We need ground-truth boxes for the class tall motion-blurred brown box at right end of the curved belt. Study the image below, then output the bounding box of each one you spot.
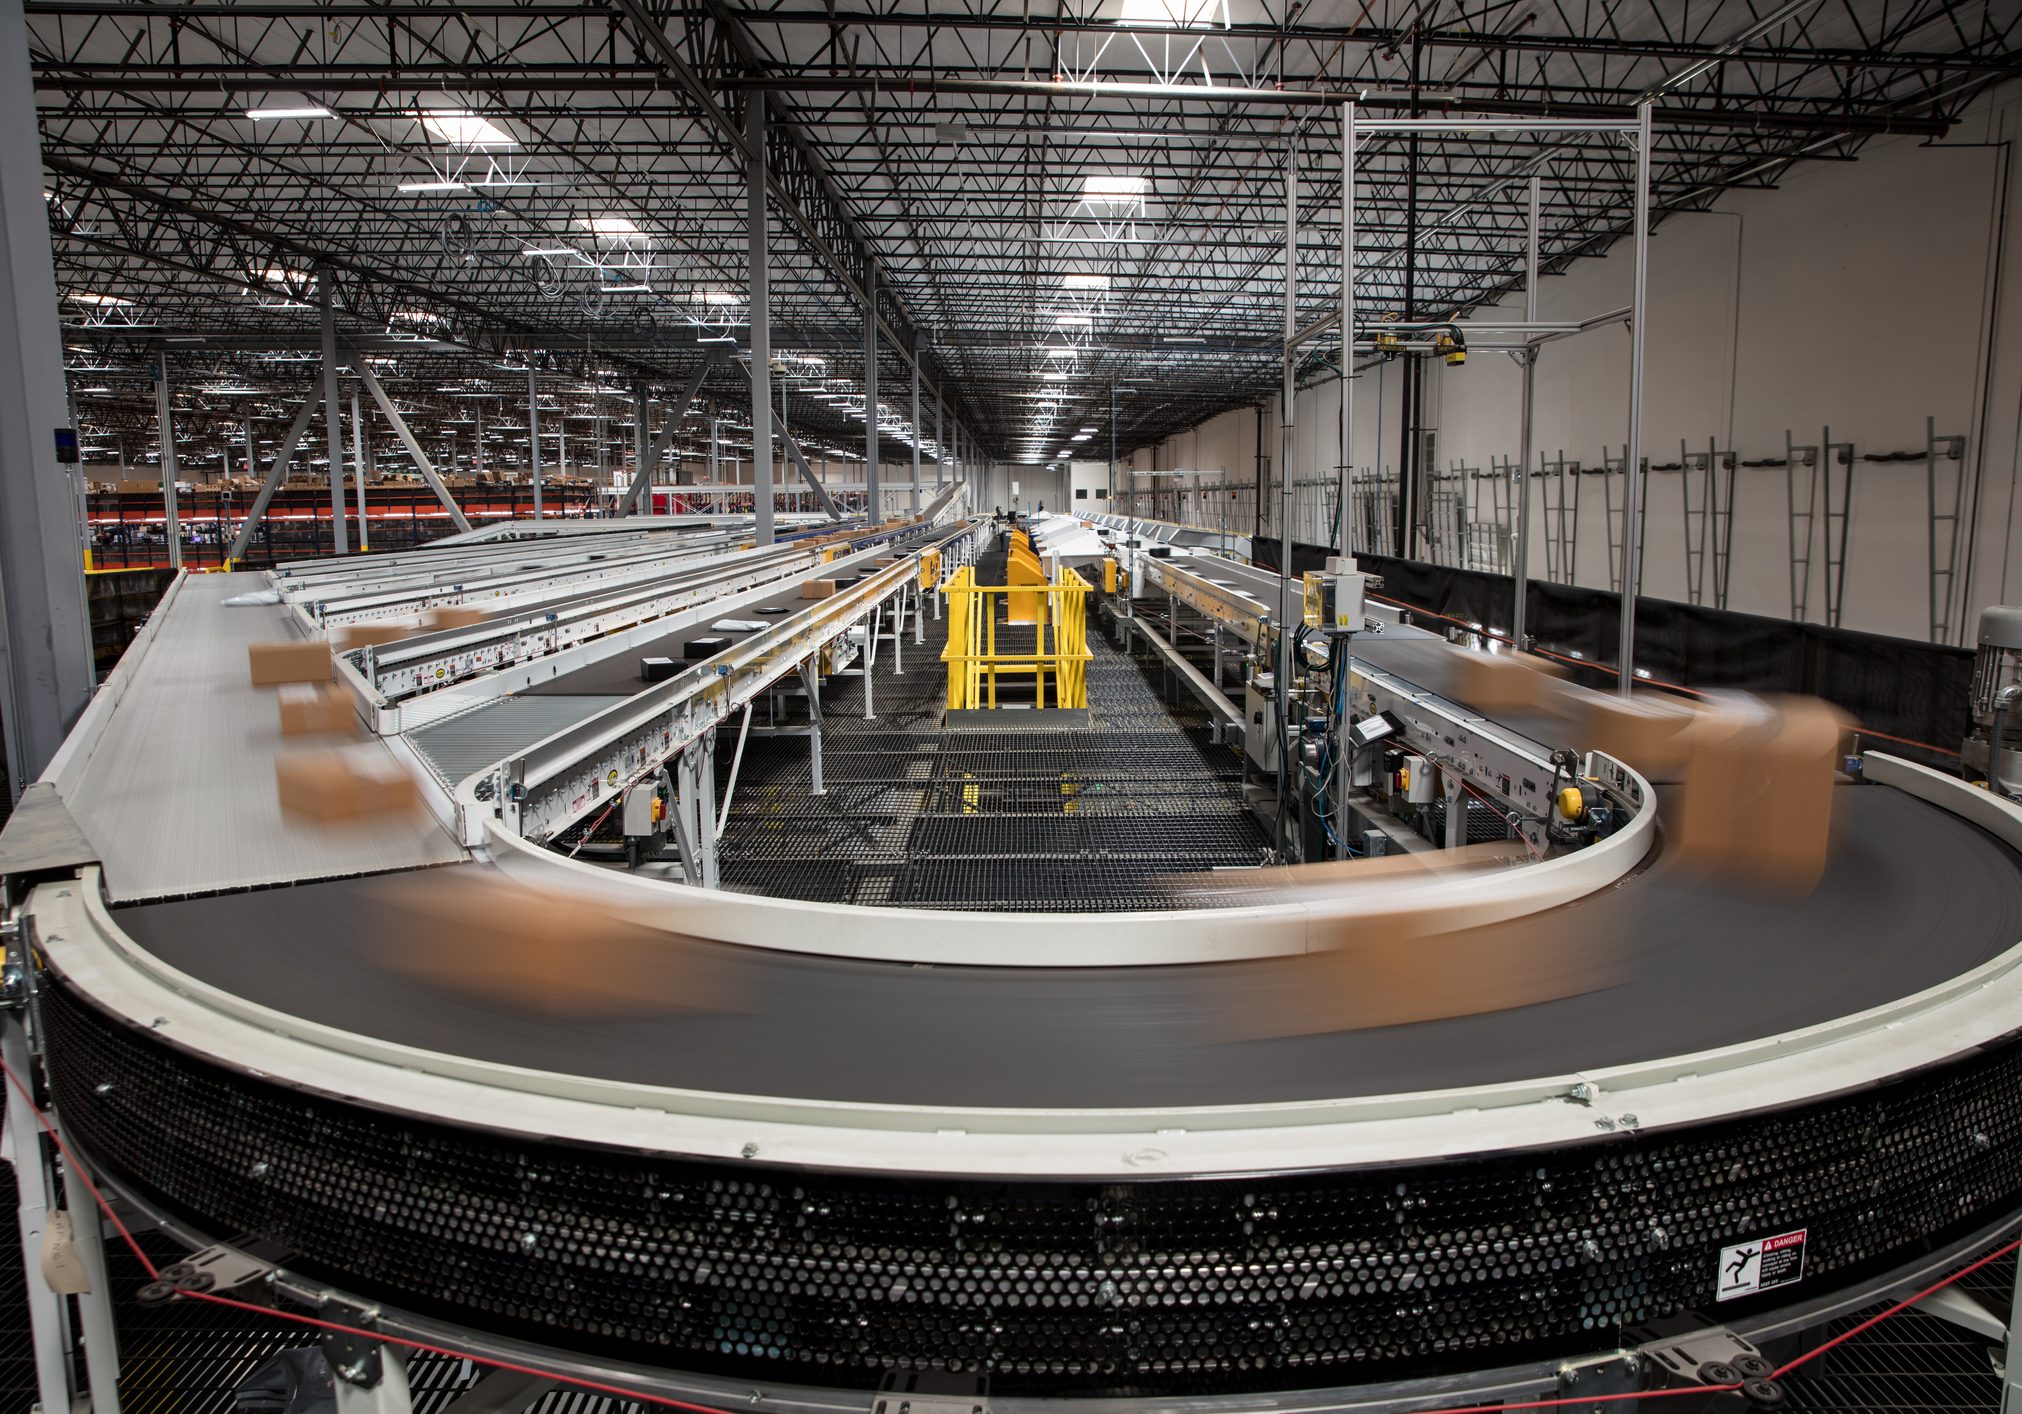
[1670,698,1848,894]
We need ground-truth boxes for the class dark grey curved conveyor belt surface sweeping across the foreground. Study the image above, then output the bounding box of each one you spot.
[119,785,2022,1109]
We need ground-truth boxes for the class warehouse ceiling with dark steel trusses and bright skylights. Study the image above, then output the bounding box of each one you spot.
[26,0,2022,475]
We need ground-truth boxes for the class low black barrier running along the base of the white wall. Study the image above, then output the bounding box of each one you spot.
[1256,540,1973,765]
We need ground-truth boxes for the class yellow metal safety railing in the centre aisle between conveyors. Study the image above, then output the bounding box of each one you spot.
[940,562,1094,712]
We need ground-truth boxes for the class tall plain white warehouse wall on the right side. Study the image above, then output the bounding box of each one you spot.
[1138,85,2022,641]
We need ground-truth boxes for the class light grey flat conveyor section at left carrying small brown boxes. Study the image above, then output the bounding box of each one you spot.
[65,575,463,900]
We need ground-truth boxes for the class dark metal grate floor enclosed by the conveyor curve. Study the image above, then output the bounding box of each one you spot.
[718,590,1268,912]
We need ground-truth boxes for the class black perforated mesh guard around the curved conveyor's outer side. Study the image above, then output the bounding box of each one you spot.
[42,983,2022,1396]
